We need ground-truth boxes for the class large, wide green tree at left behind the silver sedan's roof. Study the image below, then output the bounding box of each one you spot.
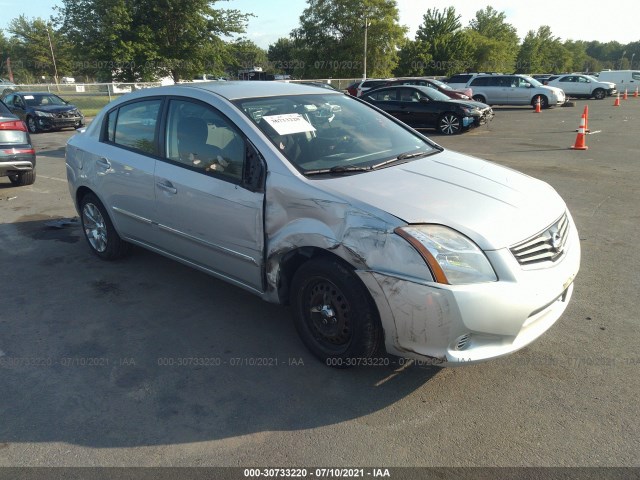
[57,0,248,81]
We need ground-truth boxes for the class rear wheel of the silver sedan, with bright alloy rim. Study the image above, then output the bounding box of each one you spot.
[80,193,131,260]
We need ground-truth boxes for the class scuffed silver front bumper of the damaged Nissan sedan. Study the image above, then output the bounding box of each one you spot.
[360,212,580,366]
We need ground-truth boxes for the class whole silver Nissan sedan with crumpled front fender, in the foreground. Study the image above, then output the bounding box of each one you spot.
[66,82,580,367]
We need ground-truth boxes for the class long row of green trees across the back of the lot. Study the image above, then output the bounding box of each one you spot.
[0,0,640,83]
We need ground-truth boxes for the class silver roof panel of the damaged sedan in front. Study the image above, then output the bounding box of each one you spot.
[171,80,342,100]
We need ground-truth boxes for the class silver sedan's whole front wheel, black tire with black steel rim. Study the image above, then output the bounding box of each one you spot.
[291,257,382,368]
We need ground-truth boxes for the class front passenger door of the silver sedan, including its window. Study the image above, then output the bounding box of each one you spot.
[155,98,264,291]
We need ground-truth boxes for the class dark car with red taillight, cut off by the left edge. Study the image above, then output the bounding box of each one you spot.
[0,100,36,186]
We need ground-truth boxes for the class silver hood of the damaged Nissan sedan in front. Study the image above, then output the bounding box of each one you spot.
[312,151,566,250]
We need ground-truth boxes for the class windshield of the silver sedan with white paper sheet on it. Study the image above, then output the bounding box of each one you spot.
[234,93,439,174]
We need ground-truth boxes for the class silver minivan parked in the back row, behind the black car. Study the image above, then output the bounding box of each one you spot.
[467,75,566,108]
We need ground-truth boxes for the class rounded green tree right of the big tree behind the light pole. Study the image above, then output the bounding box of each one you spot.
[416,7,473,75]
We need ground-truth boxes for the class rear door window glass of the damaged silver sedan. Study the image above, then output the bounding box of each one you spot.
[105,99,162,155]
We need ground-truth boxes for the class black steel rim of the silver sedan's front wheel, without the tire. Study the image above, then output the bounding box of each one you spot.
[305,278,352,350]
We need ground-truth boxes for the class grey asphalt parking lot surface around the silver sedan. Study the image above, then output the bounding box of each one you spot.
[0,98,640,467]
